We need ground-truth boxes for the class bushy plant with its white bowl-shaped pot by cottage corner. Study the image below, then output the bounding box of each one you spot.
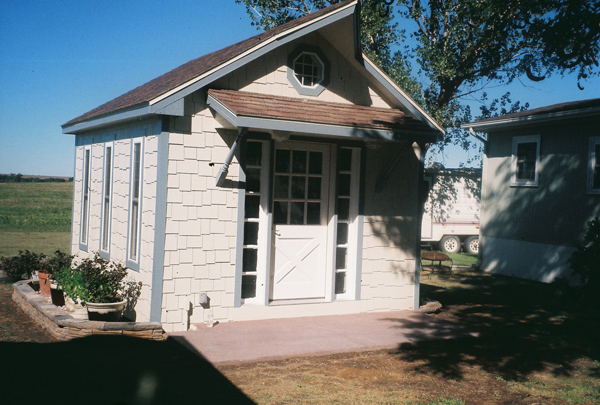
[74,253,142,321]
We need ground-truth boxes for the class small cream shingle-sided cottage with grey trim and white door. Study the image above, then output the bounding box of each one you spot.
[63,1,443,331]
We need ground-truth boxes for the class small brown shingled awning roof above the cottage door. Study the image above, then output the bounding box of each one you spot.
[208,89,439,142]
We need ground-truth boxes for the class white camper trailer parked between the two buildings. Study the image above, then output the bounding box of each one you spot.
[421,169,481,254]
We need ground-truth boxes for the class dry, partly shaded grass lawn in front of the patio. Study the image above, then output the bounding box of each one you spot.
[219,270,600,405]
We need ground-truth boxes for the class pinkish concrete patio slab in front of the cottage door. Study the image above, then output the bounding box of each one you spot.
[167,311,478,364]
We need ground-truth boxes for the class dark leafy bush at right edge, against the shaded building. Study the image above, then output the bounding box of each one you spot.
[569,217,600,298]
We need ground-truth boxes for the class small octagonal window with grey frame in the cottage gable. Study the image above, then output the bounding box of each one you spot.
[288,46,329,96]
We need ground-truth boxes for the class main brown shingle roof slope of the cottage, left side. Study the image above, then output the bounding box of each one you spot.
[63,0,350,126]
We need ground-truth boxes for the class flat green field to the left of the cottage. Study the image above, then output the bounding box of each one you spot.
[0,182,73,256]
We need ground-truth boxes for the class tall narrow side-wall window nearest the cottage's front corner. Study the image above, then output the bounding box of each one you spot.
[127,141,142,263]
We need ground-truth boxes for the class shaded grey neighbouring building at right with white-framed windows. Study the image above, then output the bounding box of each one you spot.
[463,99,600,282]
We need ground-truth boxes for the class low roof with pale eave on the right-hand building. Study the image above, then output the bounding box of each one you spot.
[461,98,600,131]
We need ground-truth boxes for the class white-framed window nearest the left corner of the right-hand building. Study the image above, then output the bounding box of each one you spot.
[511,135,540,186]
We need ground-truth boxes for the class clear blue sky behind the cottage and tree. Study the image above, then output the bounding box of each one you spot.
[0,0,600,176]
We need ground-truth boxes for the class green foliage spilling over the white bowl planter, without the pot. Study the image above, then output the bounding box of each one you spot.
[53,253,142,303]
